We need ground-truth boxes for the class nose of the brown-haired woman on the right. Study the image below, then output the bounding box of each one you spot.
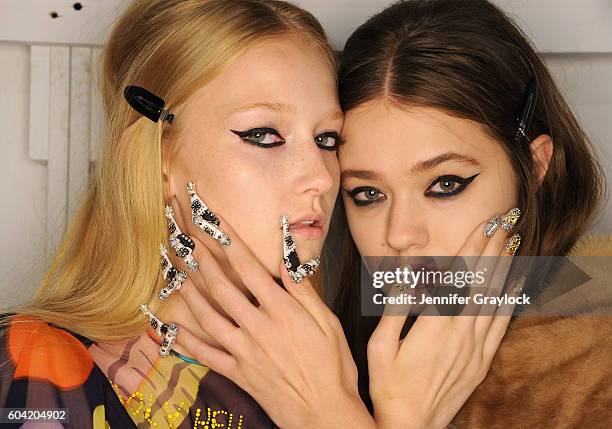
[386,199,430,256]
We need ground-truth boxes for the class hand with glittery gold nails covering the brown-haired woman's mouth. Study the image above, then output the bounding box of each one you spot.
[368,212,518,429]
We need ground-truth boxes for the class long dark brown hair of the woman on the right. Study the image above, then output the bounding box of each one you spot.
[335,0,604,410]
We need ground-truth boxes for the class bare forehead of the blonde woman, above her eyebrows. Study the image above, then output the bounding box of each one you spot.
[184,35,337,113]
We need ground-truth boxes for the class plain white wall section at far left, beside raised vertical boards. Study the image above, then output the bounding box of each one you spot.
[0,43,47,304]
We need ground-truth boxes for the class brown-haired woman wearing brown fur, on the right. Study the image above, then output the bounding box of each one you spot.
[336,0,612,428]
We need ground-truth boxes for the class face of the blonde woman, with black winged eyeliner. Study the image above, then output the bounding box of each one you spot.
[165,36,343,276]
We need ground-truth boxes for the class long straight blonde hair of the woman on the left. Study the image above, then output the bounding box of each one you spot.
[5,0,335,341]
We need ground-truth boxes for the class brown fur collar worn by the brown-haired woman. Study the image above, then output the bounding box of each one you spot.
[449,234,612,429]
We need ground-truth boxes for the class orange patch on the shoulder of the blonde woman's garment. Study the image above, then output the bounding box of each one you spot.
[0,315,94,389]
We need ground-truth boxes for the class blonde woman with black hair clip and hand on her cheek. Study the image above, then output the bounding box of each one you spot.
[0,0,505,429]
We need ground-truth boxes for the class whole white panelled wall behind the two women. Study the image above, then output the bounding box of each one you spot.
[0,0,612,308]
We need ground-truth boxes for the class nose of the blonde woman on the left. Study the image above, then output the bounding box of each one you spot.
[291,139,340,195]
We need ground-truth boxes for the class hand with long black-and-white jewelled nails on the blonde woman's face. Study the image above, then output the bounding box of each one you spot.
[170,204,374,428]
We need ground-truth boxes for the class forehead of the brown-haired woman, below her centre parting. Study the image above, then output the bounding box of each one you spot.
[339,100,502,169]
